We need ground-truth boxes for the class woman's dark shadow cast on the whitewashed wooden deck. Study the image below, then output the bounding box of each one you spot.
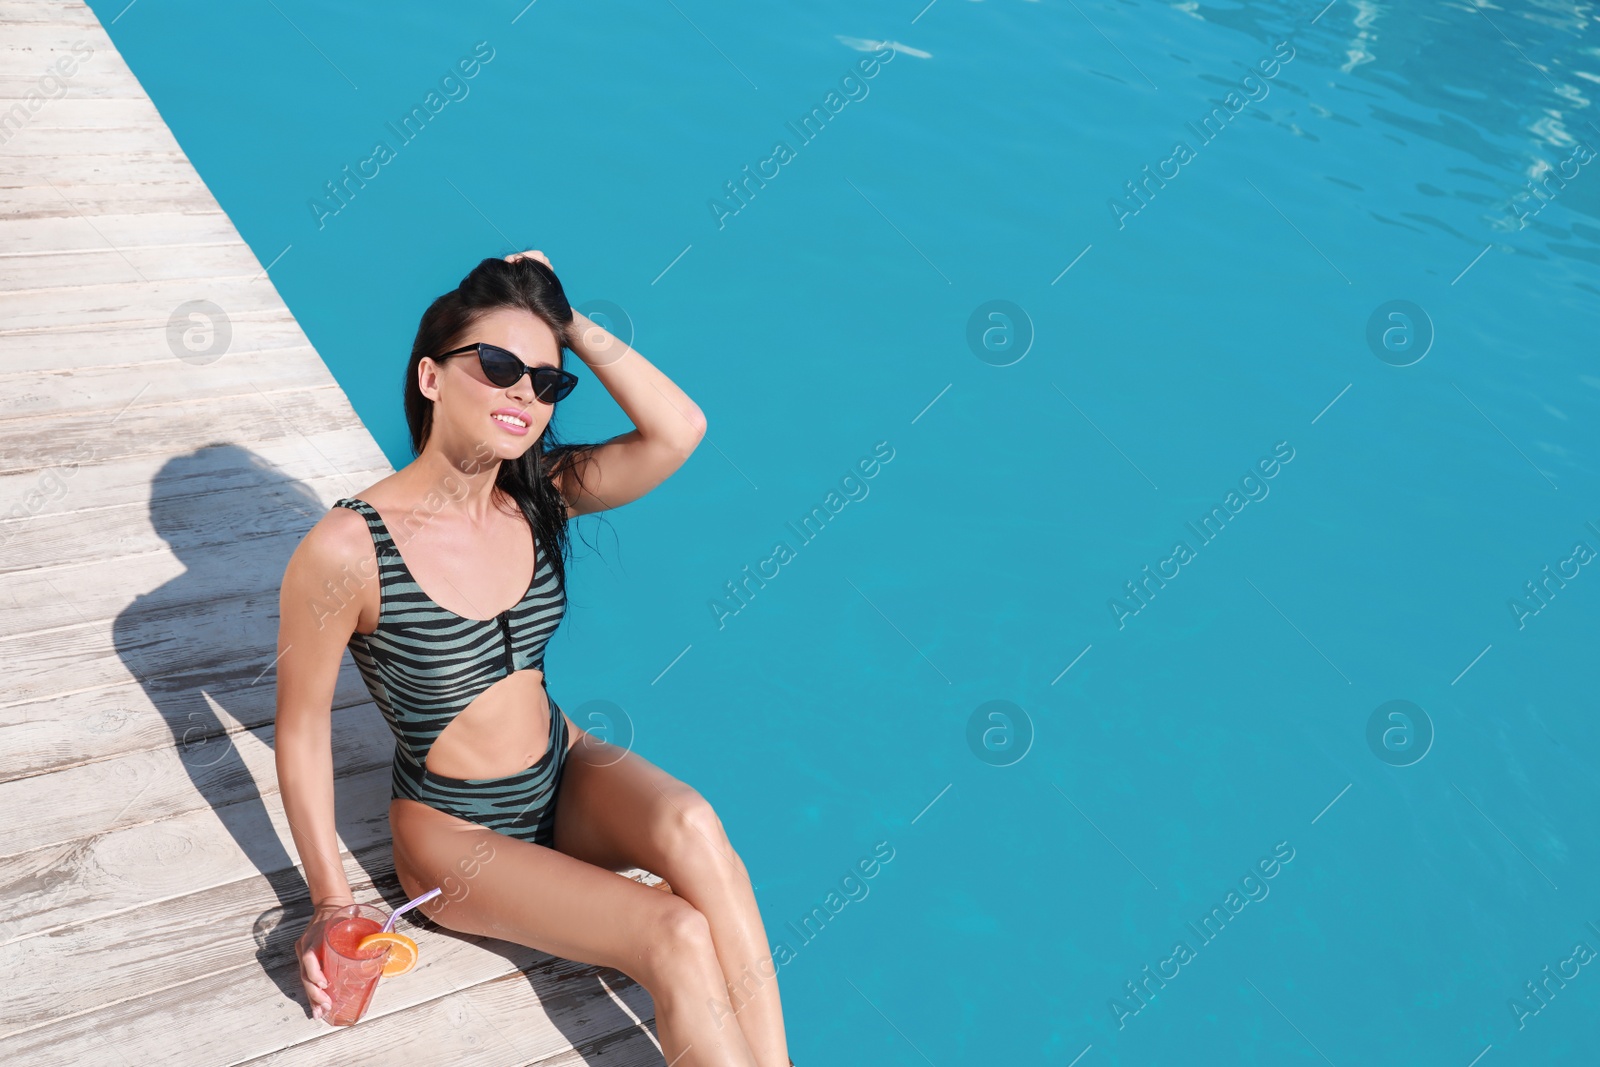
[112,443,652,1062]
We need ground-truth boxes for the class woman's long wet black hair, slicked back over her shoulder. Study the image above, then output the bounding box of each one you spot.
[405,256,597,589]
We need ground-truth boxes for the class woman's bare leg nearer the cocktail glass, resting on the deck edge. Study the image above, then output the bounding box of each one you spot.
[389,798,758,1067]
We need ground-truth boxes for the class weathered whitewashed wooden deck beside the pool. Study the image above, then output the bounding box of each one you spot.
[0,0,662,1067]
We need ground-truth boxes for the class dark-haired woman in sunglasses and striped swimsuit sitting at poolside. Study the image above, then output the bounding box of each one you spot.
[275,251,792,1067]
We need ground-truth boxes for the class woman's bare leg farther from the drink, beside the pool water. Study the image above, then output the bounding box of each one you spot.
[554,720,789,1067]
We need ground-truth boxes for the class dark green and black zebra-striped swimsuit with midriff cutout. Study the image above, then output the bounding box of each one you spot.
[334,496,568,846]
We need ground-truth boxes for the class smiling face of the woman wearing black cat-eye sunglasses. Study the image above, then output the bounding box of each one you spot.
[419,307,562,459]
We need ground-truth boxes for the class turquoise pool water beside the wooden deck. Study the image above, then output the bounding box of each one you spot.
[93,0,1600,1067]
